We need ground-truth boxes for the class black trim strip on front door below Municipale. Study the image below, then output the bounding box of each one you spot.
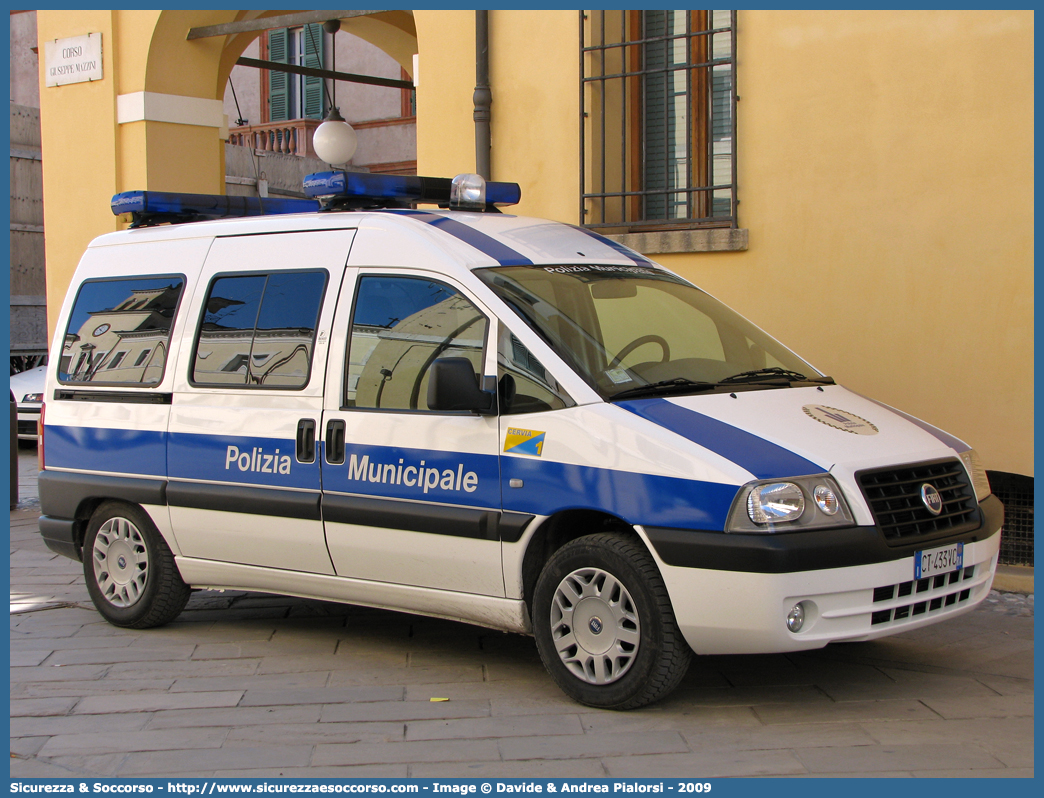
[323,494,500,540]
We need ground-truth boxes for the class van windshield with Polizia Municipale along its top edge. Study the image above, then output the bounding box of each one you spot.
[475,265,832,400]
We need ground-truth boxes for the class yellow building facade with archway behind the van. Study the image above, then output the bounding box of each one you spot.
[39,10,1034,476]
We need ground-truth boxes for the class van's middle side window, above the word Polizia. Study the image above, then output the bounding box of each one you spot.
[192,272,327,389]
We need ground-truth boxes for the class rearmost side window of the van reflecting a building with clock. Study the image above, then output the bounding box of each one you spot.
[58,276,185,385]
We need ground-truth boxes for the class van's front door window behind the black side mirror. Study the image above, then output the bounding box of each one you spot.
[345,277,489,410]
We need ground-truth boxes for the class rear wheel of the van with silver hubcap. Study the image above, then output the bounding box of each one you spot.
[84,501,191,629]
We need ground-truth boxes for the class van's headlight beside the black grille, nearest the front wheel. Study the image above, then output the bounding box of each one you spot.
[726,474,855,533]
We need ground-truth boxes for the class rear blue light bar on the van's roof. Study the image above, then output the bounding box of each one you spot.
[112,191,319,225]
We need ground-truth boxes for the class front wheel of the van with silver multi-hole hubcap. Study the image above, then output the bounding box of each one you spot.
[532,533,692,709]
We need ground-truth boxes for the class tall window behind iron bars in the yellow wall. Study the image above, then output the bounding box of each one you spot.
[580,10,737,232]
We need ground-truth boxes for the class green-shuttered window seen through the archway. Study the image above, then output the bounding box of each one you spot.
[267,24,327,122]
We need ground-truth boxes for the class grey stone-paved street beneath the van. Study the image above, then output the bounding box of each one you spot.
[10,449,1034,778]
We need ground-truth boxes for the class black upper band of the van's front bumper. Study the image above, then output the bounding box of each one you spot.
[644,496,1003,578]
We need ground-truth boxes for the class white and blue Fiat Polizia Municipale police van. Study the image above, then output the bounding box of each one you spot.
[40,171,1003,709]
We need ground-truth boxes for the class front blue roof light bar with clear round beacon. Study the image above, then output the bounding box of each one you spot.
[304,170,522,206]
